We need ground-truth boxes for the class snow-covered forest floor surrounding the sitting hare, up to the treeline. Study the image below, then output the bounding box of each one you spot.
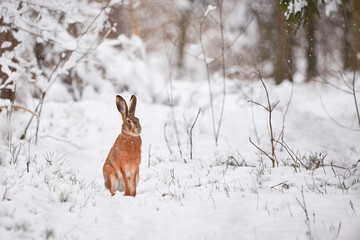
[0,79,360,240]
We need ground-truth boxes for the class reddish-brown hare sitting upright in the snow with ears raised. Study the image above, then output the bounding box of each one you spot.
[103,95,141,197]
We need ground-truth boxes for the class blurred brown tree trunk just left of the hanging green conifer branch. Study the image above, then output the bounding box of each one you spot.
[274,0,292,84]
